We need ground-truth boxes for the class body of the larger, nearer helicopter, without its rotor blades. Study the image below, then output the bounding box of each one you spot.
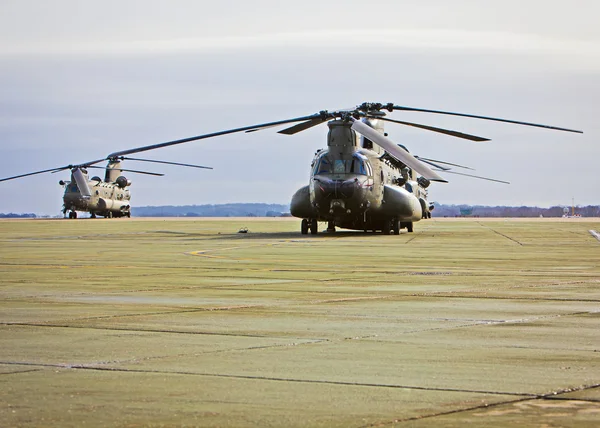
[290,120,430,234]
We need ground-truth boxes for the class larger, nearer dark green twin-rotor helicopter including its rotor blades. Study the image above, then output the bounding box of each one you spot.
[103,103,582,235]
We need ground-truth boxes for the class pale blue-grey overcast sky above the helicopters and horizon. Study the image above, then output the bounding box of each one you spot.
[0,0,600,215]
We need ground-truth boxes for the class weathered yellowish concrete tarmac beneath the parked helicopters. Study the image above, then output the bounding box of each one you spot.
[0,218,600,427]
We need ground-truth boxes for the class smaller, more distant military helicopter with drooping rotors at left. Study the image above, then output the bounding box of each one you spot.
[0,156,212,219]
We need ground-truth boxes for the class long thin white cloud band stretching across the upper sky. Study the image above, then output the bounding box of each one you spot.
[0,29,600,60]
